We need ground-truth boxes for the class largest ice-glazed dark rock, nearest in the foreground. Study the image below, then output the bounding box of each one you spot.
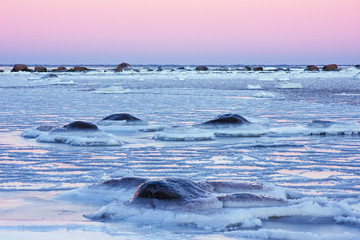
[89,177,292,215]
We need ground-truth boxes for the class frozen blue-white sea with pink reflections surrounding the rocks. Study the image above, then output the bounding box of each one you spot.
[0,66,360,240]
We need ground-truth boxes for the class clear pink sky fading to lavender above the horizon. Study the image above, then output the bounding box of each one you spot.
[0,0,360,65]
